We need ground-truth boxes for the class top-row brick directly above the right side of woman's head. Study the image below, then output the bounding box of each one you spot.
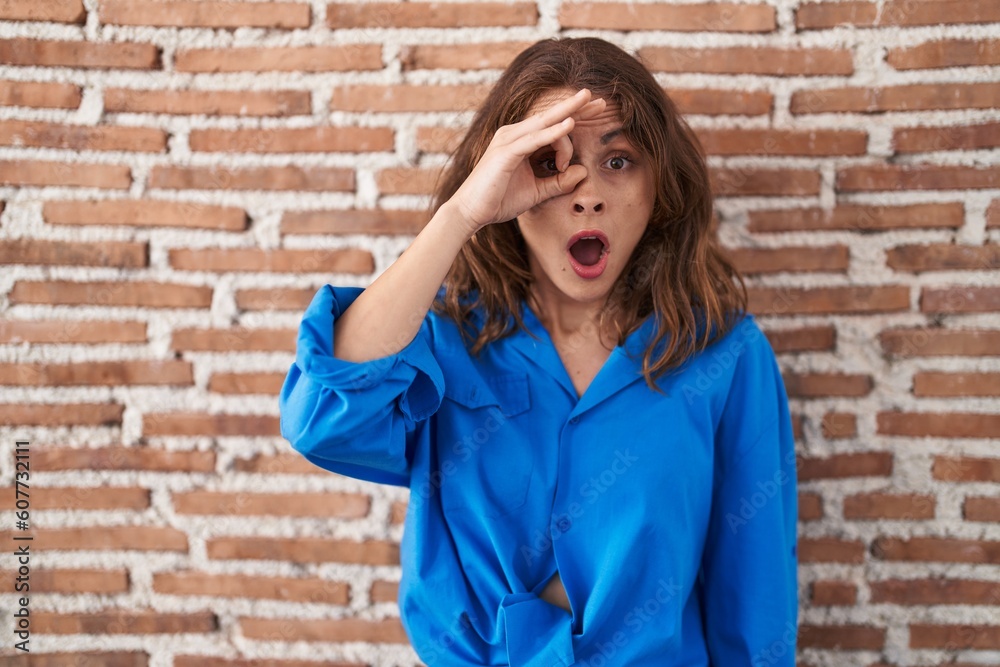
[559,2,777,32]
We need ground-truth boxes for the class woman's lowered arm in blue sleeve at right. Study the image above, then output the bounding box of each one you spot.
[701,319,798,667]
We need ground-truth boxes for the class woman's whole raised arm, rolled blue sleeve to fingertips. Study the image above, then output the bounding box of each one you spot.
[278,91,604,486]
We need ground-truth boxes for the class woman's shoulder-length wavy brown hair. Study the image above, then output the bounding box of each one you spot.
[432,37,747,391]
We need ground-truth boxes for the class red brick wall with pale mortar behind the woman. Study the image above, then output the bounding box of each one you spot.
[0,0,1000,667]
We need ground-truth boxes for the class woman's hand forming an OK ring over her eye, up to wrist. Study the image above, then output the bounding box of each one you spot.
[449,89,605,233]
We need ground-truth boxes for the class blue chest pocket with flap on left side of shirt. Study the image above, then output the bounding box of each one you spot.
[437,373,532,518]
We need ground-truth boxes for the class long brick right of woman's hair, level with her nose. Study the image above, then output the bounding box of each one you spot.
[747,202,965,232]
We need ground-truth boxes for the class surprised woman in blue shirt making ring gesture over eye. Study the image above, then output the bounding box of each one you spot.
[281,38,797,667]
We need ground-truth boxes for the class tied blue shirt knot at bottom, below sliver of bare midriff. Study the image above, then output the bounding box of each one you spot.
[497,592,576,667]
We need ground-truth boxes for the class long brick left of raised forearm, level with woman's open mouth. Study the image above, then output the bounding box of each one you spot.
[169,248,375,274]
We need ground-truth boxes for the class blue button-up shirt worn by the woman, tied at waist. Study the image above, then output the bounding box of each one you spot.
[280,285,798,667]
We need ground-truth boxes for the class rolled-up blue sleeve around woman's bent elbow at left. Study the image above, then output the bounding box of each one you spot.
[279,285,444,486]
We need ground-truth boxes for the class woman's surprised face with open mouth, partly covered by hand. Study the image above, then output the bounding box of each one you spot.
[517,90,656,310]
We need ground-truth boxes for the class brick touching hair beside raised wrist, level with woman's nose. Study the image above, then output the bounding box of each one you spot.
[281,209,429,235]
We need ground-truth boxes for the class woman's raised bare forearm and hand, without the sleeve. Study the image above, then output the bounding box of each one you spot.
[333,90,604,362]
